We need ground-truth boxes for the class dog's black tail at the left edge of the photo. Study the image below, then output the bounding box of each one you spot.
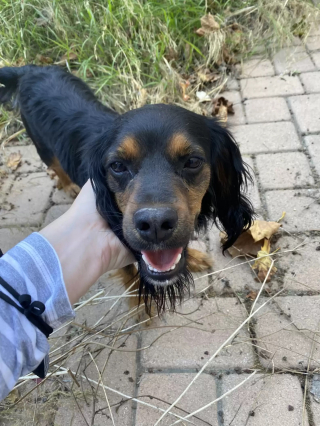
[0,66,28,105]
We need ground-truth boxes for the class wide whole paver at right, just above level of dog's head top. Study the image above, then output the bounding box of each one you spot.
[240,75,304,98]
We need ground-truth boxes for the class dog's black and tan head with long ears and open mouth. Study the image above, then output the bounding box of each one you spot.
[90,105,253,310]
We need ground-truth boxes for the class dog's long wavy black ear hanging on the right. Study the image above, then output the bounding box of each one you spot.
[201,119,254,250]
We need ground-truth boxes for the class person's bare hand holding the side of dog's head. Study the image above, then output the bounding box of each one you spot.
[40,181,135,304]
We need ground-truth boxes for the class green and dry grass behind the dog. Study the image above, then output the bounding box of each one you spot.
[0,0,315,125]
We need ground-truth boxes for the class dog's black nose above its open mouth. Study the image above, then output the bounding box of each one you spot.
[133,207,178,243]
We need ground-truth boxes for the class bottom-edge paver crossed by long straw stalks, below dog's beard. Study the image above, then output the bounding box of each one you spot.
[136,373,219,426]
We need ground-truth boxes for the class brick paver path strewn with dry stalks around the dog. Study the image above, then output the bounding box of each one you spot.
[0,26,320,426]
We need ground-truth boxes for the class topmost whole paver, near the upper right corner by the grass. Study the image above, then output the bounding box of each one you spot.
[274,46,315,74]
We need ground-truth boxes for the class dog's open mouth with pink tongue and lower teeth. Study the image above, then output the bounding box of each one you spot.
[141,247,184,281]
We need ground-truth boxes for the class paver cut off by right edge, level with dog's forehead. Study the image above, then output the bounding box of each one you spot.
[289,94,320,133]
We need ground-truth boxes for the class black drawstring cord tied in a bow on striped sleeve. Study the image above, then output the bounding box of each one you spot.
[0,249,53,379]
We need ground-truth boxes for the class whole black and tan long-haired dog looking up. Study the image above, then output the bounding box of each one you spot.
[0,65,253,312]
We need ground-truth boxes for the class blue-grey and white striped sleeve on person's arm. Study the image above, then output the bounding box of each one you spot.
[0,232,74,401]
